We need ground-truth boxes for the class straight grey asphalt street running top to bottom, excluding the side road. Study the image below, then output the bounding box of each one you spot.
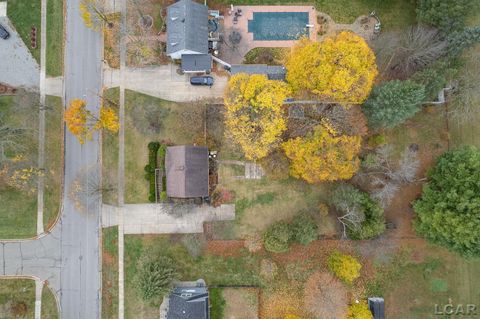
[60,0,102,319]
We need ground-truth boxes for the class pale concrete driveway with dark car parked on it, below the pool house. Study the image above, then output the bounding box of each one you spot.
[104,64,228,102]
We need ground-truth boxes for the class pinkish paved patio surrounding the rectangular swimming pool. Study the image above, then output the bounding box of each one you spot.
[220,6,317,64]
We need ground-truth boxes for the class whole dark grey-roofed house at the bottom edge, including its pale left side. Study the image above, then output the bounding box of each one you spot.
[160,279,210,319]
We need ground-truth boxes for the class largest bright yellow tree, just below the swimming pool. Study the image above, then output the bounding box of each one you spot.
[285,31,378,104]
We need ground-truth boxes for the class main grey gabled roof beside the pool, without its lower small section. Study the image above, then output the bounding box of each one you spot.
[167,0,208,54]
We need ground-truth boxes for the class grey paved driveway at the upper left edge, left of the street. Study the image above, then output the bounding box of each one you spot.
[0,17,40,91]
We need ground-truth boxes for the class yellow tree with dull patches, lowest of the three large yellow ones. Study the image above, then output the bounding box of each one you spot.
[283,121,361,183]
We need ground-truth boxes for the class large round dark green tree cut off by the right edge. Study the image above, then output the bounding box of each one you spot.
[413,146,480,257]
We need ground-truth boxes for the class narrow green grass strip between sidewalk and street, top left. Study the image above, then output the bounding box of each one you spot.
[46,0,64,76]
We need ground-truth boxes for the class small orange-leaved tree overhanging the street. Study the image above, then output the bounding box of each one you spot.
[64,99,120,144]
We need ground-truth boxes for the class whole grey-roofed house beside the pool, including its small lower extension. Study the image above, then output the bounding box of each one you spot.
[167,0,212,72]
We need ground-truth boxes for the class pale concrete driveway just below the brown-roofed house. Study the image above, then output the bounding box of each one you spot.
[102,204,235,234]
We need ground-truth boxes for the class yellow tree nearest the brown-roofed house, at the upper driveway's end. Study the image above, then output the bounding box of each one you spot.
[224,73,290,160]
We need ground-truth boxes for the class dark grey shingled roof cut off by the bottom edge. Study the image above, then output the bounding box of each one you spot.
[167,287,210,319]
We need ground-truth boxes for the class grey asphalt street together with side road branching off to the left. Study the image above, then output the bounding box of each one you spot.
[0,0,102,319]
